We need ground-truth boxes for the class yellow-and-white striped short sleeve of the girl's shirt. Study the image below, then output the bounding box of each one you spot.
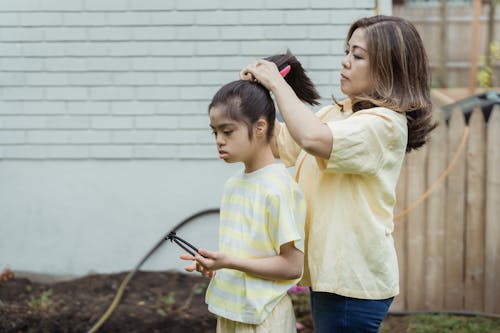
[268,185,306,253]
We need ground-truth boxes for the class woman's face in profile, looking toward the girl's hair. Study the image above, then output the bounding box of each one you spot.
[340,28,373,99]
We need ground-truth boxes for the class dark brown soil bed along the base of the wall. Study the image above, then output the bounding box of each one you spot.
[0,271,408,333]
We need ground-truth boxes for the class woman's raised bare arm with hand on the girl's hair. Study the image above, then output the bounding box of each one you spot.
[240,60,333,159]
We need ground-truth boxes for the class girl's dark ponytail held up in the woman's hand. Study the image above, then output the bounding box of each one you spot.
[265,50,321,105]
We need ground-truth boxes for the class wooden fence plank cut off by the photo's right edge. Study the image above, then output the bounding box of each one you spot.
[485,105,500,313]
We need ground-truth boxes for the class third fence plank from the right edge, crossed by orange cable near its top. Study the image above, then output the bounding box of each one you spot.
[444,109,465,310]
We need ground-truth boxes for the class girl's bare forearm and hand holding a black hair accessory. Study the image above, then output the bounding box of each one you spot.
[181,242,304,280]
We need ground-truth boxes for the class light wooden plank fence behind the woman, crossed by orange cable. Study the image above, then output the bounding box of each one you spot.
[391,105,500,314]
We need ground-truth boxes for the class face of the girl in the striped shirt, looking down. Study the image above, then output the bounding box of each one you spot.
[210,107,254,163]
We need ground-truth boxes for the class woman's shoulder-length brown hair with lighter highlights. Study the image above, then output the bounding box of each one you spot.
[346,15,436,152]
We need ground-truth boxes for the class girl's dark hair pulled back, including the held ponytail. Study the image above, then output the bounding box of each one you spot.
[208,50,320,141]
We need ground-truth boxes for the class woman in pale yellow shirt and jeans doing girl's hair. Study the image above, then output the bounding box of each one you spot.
[240,16,435,333]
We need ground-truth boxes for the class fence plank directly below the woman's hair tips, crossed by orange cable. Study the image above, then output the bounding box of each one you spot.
[406,146,427,310]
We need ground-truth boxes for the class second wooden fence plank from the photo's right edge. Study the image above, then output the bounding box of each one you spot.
[465,108,486,311]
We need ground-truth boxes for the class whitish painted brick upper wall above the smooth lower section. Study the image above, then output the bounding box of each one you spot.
[0,0,375,160]
